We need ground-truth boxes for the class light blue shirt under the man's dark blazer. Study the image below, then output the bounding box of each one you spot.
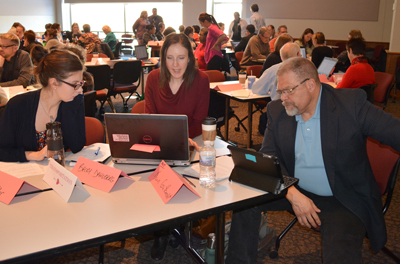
[294,86,332,196]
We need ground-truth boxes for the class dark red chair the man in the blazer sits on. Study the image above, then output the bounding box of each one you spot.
[269,138,400,263]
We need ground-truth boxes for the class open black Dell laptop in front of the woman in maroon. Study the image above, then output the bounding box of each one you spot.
[104,113,194,166]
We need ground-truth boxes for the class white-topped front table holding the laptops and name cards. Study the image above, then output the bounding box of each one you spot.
[0,139,283,263]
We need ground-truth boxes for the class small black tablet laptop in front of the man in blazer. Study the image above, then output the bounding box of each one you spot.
[228,146,299,195]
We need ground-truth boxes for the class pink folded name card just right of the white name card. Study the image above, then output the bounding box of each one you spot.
[71,157,132,192]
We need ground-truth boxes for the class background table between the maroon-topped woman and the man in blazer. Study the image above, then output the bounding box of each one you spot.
[210,81,270,148]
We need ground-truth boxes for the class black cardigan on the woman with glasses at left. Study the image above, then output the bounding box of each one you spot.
[0,90,86,162]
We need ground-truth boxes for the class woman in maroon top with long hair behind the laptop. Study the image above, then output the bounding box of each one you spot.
[145,33,210,261]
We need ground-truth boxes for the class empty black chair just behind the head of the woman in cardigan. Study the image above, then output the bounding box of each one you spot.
[86,65,116,113]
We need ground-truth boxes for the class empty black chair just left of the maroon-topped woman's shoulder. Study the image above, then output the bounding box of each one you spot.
[110,61,142,108]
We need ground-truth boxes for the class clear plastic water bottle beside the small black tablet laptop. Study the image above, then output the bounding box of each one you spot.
[200,144,216,188]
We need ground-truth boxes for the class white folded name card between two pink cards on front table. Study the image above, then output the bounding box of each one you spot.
[43,159,90,203]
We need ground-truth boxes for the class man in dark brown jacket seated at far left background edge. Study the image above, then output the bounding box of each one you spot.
[0,33,33,87]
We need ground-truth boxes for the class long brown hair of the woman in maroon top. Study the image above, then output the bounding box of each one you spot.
[159,33,197,89]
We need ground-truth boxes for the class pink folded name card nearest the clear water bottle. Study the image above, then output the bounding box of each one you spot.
[149,161,201,203]
